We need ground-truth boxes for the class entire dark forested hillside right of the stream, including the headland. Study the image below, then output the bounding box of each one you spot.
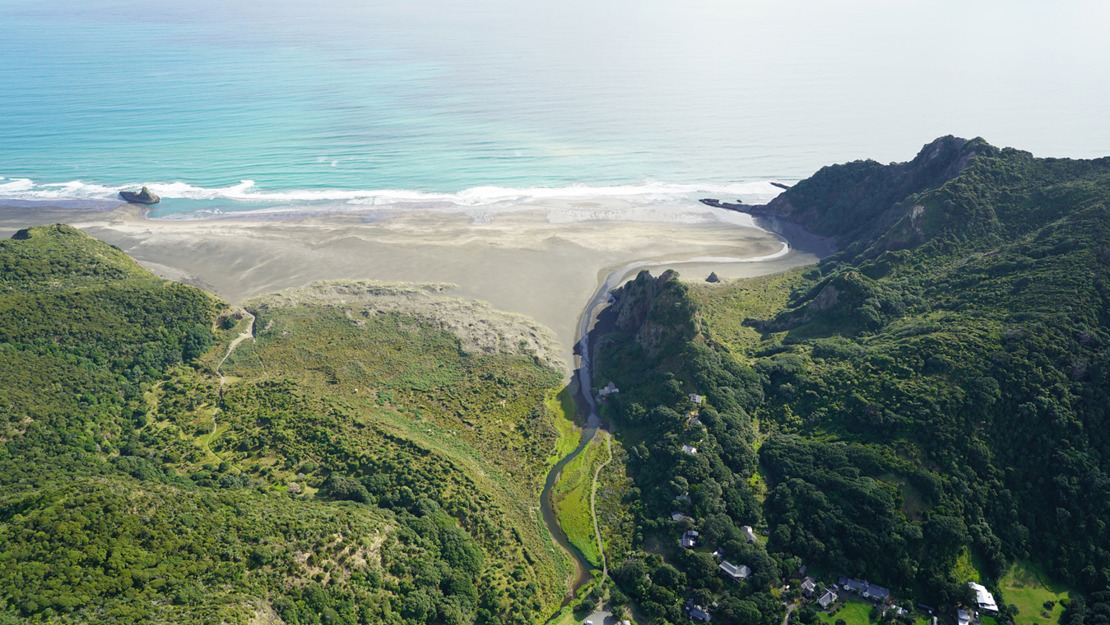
[595,138,1110,623]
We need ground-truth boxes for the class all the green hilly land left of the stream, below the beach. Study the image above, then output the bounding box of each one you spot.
[0,225,569,624]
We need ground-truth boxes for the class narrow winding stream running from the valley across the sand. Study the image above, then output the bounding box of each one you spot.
[539,242,790,606]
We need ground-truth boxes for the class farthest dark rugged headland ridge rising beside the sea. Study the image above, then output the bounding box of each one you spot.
[756,137,1110,260]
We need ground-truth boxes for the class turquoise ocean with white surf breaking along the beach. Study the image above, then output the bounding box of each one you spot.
[0,0,1110,216]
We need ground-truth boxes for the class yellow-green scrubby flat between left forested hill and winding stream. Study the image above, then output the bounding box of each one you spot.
[214,297,562,621]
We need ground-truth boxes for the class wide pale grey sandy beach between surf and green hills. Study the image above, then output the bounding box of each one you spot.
[0,197,820,363]
